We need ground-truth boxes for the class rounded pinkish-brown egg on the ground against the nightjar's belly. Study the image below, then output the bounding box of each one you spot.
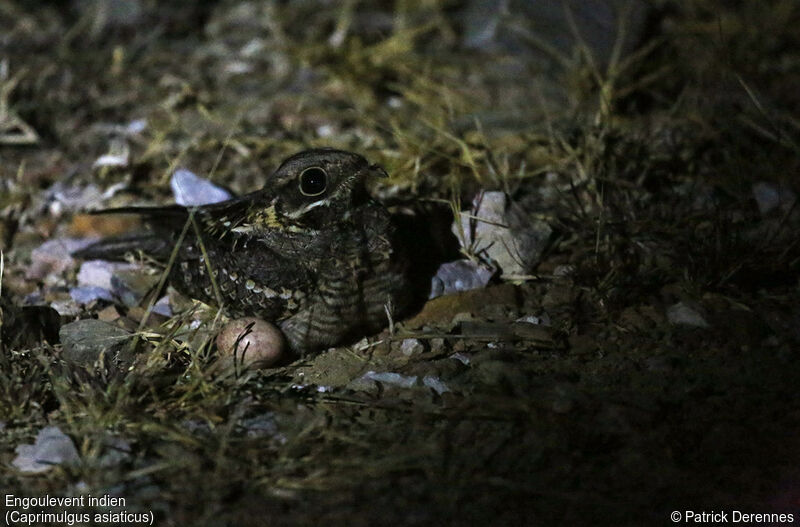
[217,317,286,368]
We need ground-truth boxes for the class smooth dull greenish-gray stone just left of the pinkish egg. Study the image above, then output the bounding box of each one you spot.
[59,319,133,367]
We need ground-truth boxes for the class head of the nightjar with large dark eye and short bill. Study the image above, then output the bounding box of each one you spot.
[263,149,386,229]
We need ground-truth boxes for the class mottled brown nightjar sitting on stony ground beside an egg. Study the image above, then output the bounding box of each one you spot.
[76,149,414,352]
